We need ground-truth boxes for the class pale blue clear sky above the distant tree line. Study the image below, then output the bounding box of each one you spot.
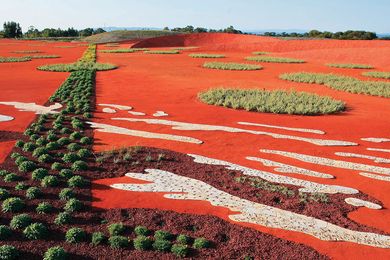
[0,0,390,33]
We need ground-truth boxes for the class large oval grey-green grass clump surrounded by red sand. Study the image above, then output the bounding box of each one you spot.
[198,88,345,115]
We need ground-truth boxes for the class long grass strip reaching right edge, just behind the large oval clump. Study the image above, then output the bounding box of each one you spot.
[279,72,390,98]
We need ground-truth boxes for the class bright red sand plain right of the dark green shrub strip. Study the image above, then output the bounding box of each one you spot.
[93,34,390,259]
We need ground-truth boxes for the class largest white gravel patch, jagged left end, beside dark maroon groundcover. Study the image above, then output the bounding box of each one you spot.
[111,169,390,248]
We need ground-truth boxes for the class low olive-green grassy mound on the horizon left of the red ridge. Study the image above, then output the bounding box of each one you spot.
[83,30,177,43]
